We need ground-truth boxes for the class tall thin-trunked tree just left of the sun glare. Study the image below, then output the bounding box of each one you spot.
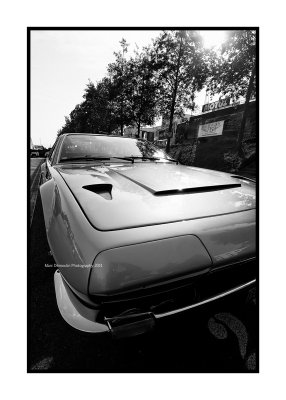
[154,30,209,151]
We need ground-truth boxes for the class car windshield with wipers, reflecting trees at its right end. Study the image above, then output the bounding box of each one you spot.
[59,135,172,162]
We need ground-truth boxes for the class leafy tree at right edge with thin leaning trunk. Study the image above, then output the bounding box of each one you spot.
[208,30,256,157]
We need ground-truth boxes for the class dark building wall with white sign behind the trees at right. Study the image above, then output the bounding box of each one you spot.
[174,100,256,171]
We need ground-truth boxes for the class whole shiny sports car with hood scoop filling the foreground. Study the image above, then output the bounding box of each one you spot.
[40,133,256,337]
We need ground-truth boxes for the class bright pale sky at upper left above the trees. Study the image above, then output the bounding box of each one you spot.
[31,30,223,147]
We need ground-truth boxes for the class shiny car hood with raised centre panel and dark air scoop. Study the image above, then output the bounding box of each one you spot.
[56,162,255,231]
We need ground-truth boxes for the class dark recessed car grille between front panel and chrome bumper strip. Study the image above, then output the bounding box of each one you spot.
[92,259,257,317]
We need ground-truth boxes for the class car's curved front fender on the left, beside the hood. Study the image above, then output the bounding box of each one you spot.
[40,168,96,294]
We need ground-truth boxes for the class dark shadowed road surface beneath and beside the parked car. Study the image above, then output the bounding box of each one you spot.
[28,159,258,372]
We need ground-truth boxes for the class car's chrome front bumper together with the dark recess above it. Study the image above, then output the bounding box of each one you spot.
[54,260,256,337]
